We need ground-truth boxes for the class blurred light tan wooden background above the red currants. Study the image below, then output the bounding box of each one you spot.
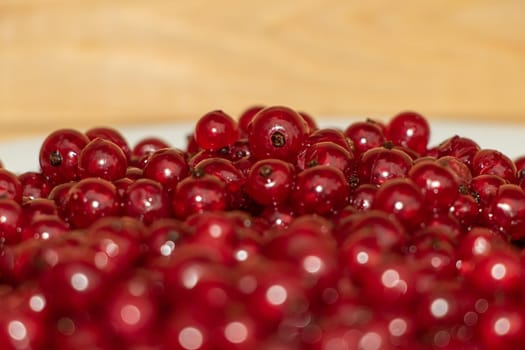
[0,0,525,139]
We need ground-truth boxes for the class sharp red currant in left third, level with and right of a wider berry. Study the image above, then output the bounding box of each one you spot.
[122,179,171,225]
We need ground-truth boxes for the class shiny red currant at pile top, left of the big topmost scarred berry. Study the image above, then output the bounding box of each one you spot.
[195,110,239,151]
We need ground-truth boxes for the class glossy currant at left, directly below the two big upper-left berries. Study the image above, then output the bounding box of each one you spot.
[65,178,120,228]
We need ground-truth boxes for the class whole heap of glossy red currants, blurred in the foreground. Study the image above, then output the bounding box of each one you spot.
[0,106,525,350]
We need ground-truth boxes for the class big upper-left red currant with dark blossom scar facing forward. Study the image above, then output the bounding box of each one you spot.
[39,129,89,184]
